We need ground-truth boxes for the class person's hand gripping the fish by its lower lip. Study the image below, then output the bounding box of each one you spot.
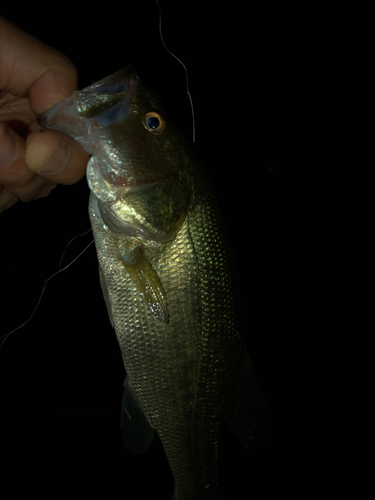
[0,15,89,213]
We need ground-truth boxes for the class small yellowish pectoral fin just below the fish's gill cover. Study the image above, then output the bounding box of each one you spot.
[119,244,169,323]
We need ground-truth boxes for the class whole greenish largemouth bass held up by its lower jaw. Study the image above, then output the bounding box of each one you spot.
[38,64,268,500]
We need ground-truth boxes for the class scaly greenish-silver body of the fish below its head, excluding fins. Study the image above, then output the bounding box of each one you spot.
[90,184,240,500]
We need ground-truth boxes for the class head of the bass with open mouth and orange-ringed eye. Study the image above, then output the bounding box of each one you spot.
[38,65,194,243]
